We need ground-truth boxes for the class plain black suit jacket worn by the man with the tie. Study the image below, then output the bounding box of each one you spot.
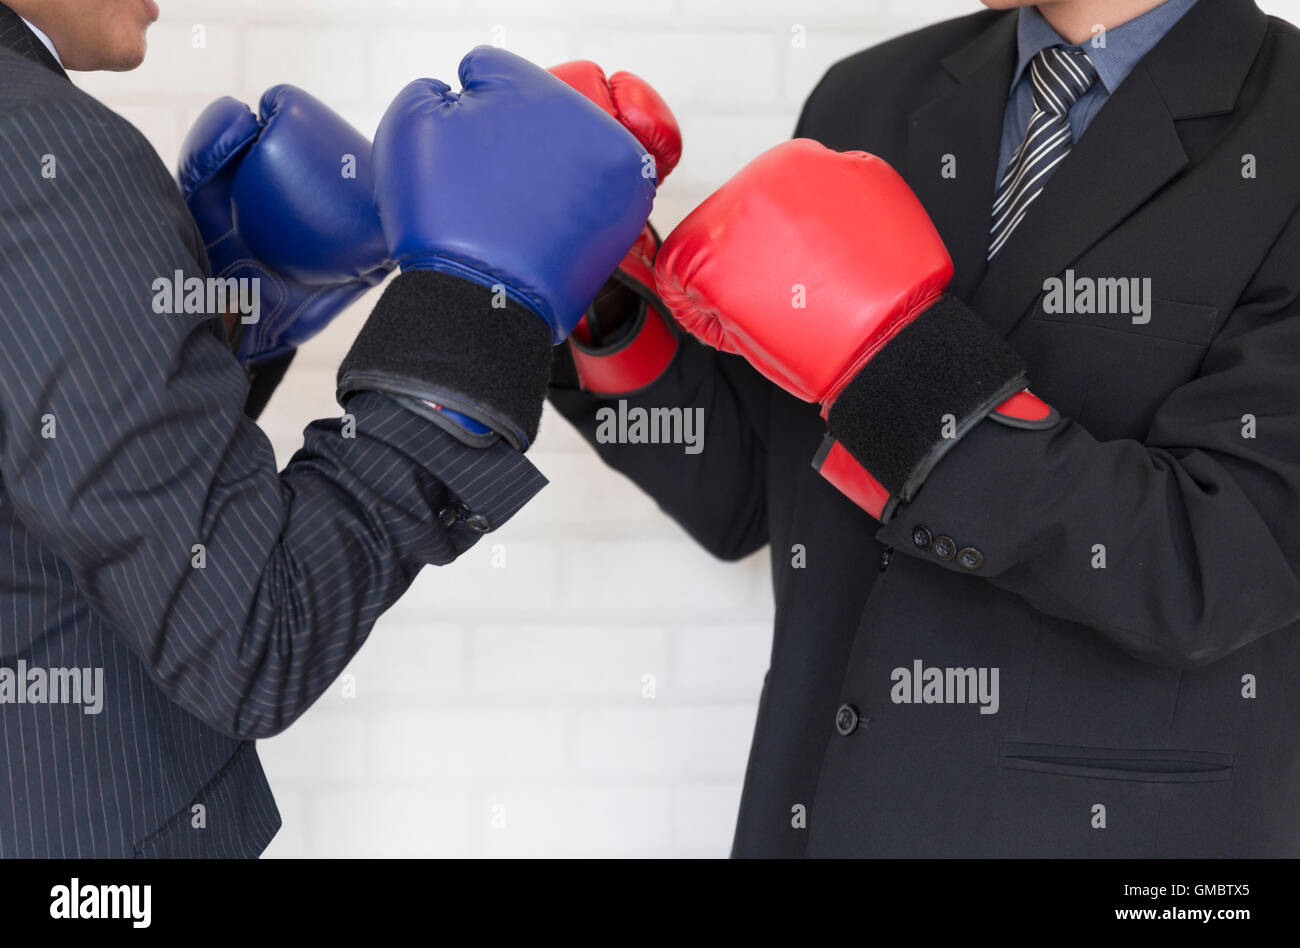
[553,0,1300,857]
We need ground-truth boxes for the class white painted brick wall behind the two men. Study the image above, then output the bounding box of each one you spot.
[77,0,1300,856]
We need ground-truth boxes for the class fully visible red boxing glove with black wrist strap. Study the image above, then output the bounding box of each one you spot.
[655,139,1058,520]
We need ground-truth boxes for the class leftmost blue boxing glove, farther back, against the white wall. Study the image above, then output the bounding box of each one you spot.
[177,86,393,367]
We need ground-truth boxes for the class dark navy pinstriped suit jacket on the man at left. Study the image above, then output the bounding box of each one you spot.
[0,5,545,857]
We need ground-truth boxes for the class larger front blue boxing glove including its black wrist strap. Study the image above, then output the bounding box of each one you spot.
[338,47,655,450]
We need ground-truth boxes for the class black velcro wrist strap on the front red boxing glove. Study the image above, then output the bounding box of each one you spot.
[827,295,1026,501]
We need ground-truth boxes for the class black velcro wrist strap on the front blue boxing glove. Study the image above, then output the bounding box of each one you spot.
[338,270,551,449]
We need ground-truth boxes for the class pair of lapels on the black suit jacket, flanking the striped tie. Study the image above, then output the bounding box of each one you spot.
[906,0,1268,333]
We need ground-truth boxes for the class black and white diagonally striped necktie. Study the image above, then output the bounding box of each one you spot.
[988,47,1097,260]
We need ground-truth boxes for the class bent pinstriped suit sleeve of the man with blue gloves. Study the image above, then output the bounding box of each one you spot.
[0,103,545,737]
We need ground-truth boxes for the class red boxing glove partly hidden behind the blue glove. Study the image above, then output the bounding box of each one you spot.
[550,60,681,395]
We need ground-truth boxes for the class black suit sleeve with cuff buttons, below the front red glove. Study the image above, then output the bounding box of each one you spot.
[879,206,1300,667]
